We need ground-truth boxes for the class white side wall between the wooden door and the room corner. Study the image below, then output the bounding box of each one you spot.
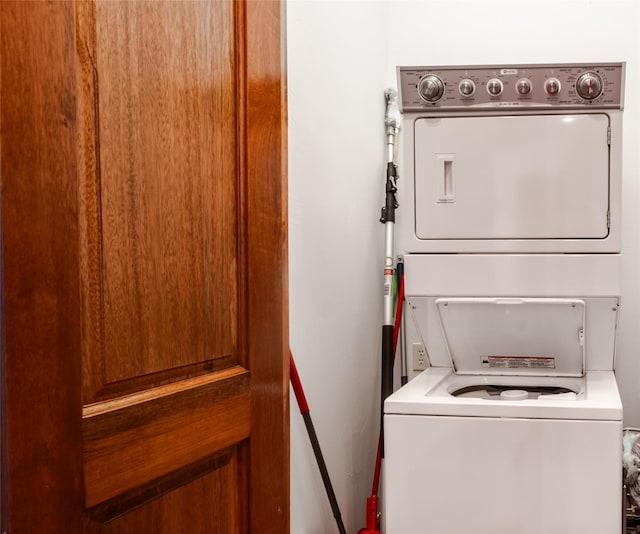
[287,1,387,534]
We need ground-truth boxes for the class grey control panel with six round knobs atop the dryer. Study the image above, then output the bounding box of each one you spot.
[398,63,625,111]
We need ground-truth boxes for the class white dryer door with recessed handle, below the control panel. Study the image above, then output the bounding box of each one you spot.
[414,113,609,240]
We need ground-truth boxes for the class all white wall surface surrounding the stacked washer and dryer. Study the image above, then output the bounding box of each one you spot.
[287,0,640,534]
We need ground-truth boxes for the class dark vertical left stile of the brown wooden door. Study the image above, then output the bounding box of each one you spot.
[0,1,82,534]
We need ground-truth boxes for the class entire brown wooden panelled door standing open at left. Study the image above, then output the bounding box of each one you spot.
[0,0,289,534]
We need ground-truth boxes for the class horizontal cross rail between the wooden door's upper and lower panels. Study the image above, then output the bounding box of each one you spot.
[84,367,250,507]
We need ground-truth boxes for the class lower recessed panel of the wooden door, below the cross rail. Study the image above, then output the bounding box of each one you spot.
[87,453,243,534]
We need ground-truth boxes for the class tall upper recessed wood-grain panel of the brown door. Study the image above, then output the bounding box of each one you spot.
[78,1,238,399]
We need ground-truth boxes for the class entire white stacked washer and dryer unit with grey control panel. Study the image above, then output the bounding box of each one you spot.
[383,63,624,534]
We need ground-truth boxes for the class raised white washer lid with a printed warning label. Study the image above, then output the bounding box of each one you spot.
[435,298,585,376]
